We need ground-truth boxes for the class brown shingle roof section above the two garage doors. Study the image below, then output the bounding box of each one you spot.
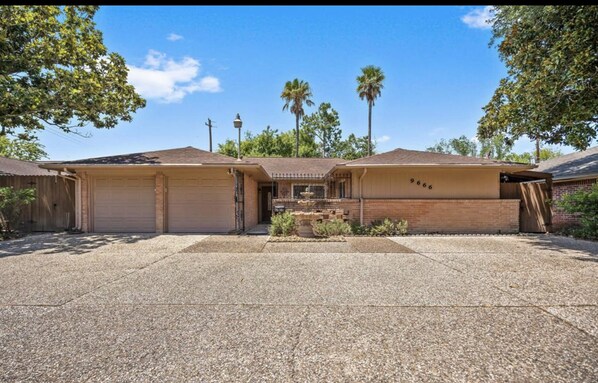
[62,146,249,165]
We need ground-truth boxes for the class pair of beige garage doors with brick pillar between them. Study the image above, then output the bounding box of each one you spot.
[89,168,235,233]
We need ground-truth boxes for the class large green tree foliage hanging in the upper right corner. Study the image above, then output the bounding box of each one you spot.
[478,5,598,150]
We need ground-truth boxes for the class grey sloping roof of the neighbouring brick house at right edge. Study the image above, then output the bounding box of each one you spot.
[536,146,598,180]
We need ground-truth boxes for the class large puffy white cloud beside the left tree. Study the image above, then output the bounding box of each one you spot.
[128,49,222,103]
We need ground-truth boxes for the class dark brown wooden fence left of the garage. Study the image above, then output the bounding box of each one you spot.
[0,176,75,232]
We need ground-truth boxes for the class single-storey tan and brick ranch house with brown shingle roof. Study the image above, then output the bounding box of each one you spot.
[42,147,534,233]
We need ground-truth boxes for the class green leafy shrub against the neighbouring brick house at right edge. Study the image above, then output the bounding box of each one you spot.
[557,183,598,239]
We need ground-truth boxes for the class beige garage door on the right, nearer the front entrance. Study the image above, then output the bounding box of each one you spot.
[168,170,235,233]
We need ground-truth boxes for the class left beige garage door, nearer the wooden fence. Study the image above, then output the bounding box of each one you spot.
[93,176,156,233]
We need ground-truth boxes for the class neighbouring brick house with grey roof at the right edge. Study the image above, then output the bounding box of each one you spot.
[536,146,598,230]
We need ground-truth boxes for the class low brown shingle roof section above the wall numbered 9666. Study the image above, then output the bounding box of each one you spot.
[345,148,532,168]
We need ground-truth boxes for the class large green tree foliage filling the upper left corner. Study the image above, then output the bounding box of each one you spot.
[0,5,145,138]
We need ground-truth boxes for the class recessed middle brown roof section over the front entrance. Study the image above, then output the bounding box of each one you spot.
[245,157,345,179]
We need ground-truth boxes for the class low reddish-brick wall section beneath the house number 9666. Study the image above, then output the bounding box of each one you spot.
[363,199,519,234]
